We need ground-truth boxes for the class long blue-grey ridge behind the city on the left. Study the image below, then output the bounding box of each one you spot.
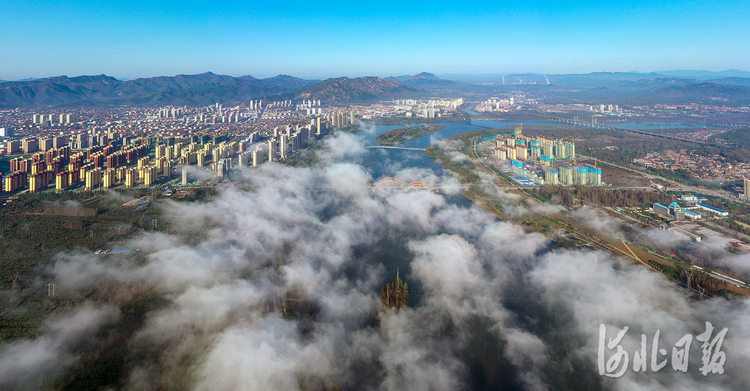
[0,72,315,108]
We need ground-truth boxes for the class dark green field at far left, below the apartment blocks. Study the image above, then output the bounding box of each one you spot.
[0,188,214,341]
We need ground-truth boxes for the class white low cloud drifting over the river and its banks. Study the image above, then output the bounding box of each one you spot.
[0,133,750,391]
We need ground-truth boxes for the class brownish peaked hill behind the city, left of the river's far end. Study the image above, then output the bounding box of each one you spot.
[296,76,419,103]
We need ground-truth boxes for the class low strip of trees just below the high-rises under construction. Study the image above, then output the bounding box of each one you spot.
[536,185,674,207]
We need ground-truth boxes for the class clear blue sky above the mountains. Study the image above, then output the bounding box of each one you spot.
[0,0,750,80]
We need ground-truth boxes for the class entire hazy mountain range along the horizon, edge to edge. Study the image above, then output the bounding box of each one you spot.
[0,71,750,108]
